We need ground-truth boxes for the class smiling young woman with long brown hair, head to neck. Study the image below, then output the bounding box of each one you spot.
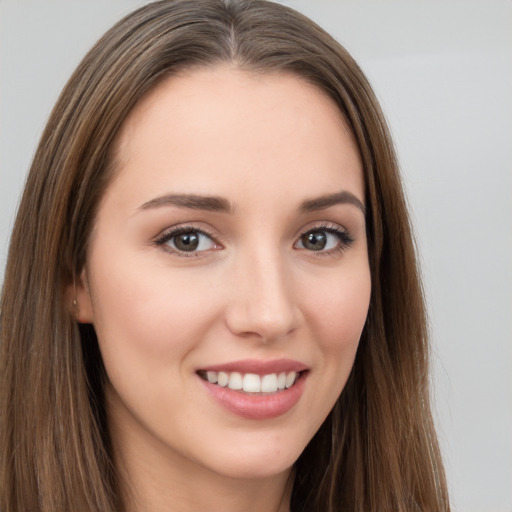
[0,0,449,511]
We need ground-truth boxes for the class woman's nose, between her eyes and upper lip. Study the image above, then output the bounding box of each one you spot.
[226,247,302,342]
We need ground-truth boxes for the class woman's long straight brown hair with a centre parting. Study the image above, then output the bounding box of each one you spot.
[0,0,449,512]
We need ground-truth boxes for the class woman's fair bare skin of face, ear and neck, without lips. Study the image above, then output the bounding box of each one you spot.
[77,65,371,512]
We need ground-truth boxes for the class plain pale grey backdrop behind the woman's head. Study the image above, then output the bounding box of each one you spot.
[0,0,512,512]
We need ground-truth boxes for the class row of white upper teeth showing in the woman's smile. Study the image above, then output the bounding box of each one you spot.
[203,370,299,393]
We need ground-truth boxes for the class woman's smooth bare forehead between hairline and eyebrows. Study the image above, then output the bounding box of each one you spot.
[108,65,364,210]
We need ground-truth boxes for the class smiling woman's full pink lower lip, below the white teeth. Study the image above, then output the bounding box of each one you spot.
[199,374,307,420]
